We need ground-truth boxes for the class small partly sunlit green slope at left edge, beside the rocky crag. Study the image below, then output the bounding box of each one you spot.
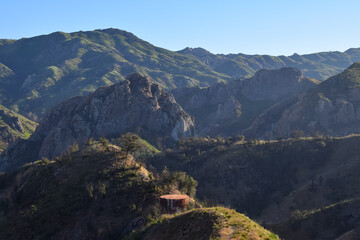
[0,105,37,152]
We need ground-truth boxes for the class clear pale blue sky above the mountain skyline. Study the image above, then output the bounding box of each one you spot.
[0,0,360,55]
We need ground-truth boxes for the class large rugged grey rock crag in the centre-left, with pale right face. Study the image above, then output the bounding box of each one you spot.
[0,73,196,170]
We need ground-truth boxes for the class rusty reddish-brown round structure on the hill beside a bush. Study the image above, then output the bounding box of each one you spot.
[160,194,190,213]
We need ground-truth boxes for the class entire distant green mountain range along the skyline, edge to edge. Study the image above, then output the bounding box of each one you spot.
[0,29,360,120]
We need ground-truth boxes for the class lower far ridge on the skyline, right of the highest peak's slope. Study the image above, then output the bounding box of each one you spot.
[178,48,360,80]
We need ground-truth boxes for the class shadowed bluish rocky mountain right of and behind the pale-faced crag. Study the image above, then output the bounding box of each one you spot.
[172,68,319,136]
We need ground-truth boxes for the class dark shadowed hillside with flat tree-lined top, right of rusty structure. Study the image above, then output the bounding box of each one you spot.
[148,136,360,227]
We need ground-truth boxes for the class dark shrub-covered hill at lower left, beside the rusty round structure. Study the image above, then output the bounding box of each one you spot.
[0,139,194,239]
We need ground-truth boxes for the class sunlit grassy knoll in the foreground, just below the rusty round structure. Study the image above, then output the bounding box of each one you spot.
[135,207,279,240]
